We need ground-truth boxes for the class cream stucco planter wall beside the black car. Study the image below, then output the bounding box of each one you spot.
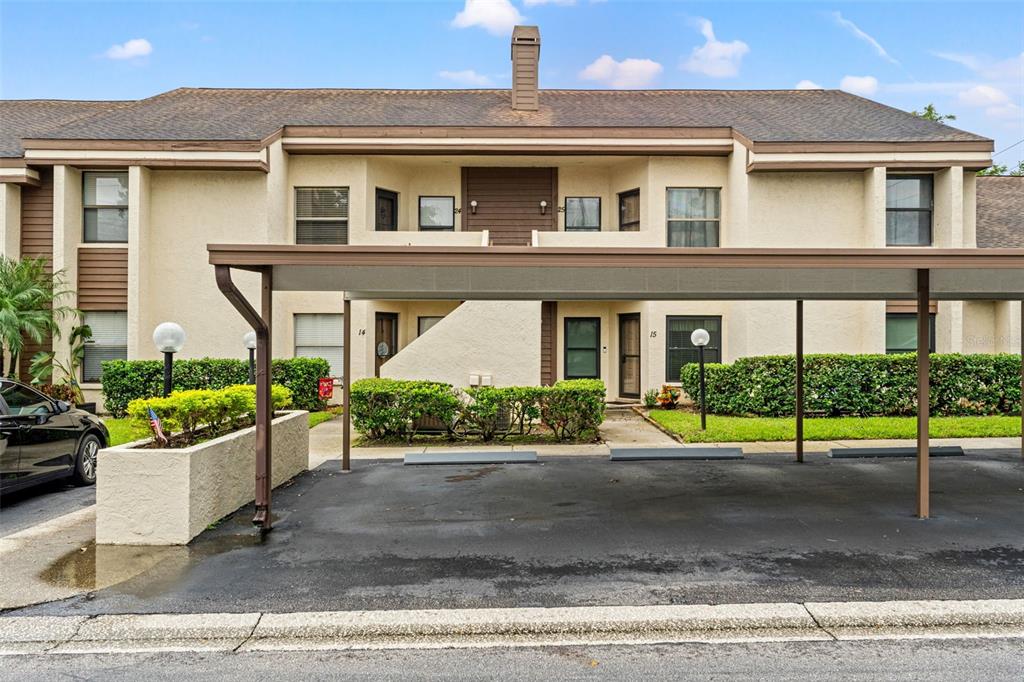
[96,411,309,545]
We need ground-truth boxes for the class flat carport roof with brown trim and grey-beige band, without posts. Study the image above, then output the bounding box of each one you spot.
[208,244,1024,300]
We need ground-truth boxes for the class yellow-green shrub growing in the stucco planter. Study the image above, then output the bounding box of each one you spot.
[128,384,292,444]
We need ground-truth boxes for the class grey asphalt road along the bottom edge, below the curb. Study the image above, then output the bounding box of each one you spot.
[0,639,1024,682]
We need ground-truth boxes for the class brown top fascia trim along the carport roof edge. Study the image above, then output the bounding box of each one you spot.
[207,244,1024,269]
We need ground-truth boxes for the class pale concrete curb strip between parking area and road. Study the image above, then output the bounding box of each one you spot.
[0,599,1024,655]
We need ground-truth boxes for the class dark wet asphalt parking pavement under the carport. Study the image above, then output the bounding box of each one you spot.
[8,451,1024,615]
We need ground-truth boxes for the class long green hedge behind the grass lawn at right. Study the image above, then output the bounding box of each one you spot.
[680,354,1021,417]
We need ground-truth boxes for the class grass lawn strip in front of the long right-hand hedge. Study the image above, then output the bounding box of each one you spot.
[649,410,1021,442]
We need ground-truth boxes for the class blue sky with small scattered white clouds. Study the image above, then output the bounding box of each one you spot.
[0,0,1024,164]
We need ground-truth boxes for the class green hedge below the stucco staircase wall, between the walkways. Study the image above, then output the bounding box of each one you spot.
[350,379,604,441]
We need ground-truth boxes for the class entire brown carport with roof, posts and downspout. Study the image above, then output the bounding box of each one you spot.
[208,244,1024,530]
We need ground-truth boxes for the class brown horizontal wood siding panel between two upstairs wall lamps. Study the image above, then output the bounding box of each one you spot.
[462,167,558,246]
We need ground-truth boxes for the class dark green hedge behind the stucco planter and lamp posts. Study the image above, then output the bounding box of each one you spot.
[99,357,331,417]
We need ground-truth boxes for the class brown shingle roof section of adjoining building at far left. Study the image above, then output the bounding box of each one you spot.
[0,99,131,158]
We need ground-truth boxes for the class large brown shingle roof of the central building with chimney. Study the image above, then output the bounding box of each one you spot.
[2,88,986,151]
